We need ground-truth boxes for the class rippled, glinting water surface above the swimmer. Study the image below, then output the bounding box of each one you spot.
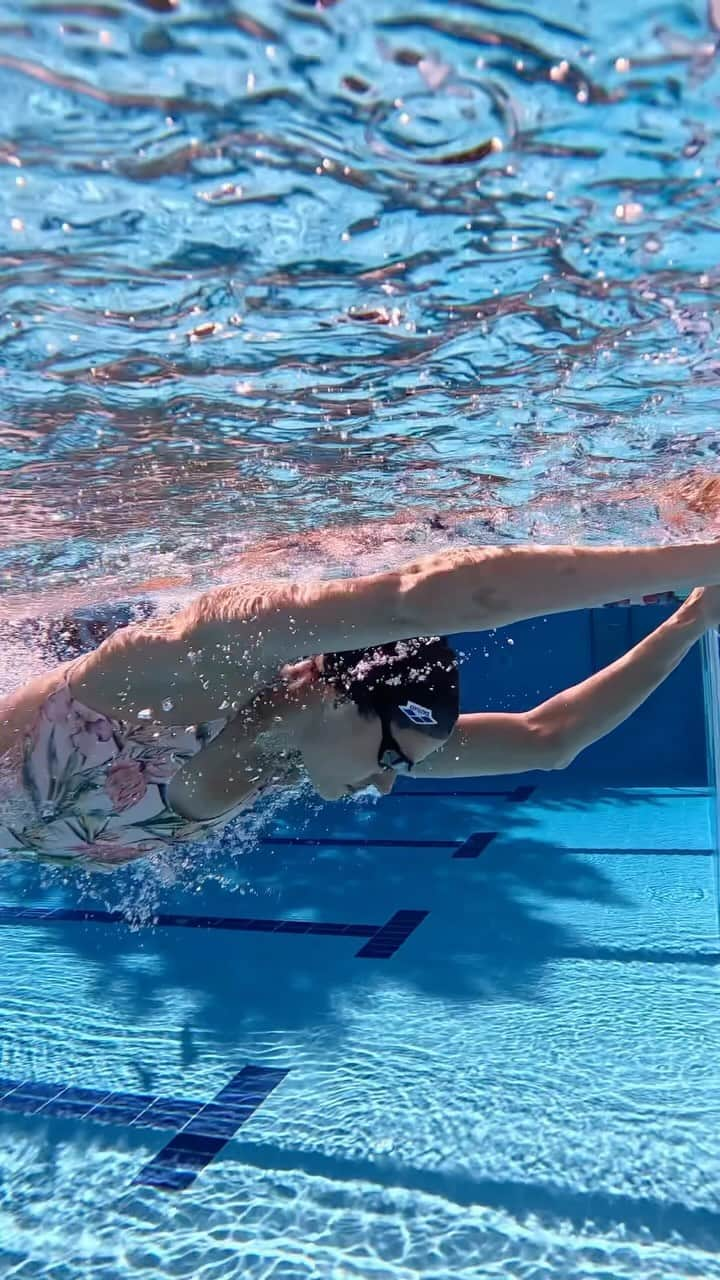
[0,0,720,612]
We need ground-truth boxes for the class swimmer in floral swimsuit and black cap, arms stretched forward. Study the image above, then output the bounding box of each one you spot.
[0,541,720,869]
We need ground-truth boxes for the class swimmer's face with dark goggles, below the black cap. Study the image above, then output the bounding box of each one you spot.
[302,698,443,800]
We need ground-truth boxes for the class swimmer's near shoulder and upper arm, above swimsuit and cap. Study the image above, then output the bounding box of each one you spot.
[72,572,421,723]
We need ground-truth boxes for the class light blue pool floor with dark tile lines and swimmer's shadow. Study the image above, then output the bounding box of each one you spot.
[0,777,720,1280]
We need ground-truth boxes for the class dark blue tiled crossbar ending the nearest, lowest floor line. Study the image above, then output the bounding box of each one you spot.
[132,1066,287,1190]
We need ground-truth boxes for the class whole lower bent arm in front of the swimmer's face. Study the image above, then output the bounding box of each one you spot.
[414,588,719,778]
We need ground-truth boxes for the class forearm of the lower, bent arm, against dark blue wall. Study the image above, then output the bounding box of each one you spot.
[520,591,711,763]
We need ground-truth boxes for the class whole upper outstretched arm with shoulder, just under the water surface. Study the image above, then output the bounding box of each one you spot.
[73,543,720,736]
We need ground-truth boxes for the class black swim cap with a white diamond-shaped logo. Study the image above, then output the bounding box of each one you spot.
[323,636,460,739]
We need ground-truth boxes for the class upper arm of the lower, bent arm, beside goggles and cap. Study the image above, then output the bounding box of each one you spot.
[413,712,568,778]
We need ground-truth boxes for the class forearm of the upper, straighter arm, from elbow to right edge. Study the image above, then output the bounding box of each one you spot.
[401,541,720,634]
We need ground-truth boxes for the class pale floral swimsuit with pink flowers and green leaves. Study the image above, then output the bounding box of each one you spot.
[0,677,231,868]
